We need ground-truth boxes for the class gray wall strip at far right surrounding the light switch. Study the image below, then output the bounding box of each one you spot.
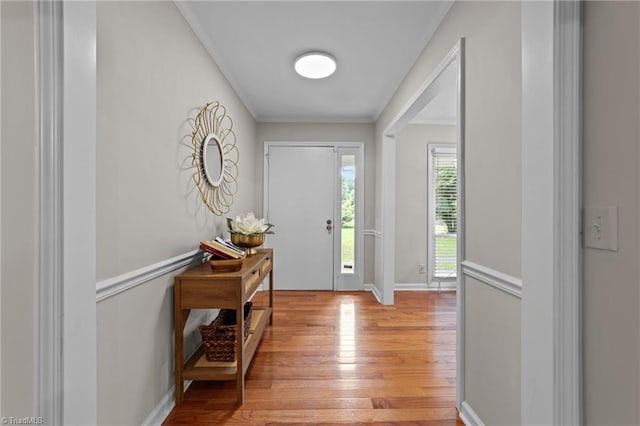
[584,2,640,425]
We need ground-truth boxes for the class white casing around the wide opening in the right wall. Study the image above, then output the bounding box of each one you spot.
[375,39,465,409]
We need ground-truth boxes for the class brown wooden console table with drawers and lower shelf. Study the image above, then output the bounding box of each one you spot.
[173,249,273,405]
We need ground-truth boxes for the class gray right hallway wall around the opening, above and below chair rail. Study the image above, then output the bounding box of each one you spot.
[376,2,522,425]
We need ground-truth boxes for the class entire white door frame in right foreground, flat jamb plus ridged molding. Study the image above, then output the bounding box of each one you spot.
[521,0,582,425]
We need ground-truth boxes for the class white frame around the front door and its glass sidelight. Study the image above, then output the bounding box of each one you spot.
[262,141,365,290]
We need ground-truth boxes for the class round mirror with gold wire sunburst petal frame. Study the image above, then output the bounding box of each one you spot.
[191,101,239,215]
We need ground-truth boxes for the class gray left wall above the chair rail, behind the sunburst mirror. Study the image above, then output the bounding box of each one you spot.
[97,2,255,280]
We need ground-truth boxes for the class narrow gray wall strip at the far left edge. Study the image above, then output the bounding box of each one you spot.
[0,2,37,417]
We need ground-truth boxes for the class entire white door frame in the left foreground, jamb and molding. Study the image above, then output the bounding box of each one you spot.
[34,0,97,424]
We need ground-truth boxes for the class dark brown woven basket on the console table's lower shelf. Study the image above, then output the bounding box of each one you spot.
[198,302,252,362]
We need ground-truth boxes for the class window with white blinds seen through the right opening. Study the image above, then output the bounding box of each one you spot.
[427,144,458,285]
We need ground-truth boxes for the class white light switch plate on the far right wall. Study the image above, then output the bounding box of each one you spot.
[584,207,618,251]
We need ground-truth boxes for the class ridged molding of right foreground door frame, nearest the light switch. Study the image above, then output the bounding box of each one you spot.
[554,1,583,425]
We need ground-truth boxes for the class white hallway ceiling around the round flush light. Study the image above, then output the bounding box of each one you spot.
[176,0,453,122]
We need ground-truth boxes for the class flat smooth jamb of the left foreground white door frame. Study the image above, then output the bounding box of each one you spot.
[61,0,98,424]
